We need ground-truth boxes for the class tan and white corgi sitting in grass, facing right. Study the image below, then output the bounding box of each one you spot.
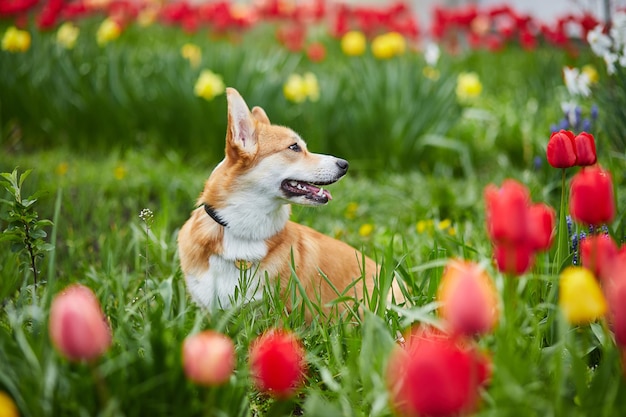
[178,88,400,314]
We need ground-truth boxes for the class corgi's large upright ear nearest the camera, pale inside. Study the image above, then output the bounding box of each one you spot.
[226,87,257,155]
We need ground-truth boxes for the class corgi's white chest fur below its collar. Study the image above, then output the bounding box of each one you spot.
[185,230,267,309]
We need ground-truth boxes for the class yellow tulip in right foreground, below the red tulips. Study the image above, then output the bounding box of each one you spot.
[559,266,607,324]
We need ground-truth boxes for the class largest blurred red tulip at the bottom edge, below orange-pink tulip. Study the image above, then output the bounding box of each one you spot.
[387,328,490,417]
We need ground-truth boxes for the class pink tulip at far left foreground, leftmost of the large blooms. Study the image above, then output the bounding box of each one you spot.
[49,284,111,362]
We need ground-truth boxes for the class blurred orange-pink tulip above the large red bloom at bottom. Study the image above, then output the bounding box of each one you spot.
[437,260,499,336]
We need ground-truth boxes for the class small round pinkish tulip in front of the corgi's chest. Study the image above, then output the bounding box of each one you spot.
[183,330,235,386]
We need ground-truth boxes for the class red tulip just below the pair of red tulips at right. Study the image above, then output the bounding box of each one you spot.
[569,166,615,226]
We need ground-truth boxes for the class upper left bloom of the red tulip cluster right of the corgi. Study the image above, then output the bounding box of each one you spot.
[485,180,530,245]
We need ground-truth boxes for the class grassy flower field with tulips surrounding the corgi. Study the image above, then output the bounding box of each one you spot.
[0,0,626,417]
